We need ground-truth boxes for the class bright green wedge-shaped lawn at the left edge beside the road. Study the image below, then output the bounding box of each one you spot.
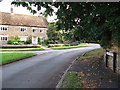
[0,52,35,64]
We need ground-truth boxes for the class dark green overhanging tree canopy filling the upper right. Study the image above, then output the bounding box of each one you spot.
[12,2,120,48]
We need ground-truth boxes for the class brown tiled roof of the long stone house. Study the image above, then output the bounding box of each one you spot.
[0,12,47,27]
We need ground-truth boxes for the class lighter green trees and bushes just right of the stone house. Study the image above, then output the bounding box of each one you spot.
[47,22,77,44]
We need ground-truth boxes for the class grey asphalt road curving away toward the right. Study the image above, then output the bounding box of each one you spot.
[1,45,100,88]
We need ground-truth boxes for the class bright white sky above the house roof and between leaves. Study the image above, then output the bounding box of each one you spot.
[0,0,56,22]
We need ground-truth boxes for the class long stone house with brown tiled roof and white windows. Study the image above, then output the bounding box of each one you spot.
[0,12,48,44]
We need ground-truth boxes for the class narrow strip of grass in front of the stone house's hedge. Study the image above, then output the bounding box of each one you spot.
[0,48,44,51]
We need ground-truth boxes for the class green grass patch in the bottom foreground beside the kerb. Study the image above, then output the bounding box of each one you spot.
[61,72,83,88]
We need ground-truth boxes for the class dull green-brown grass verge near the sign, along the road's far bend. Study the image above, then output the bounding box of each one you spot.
[80,48,104,60]
